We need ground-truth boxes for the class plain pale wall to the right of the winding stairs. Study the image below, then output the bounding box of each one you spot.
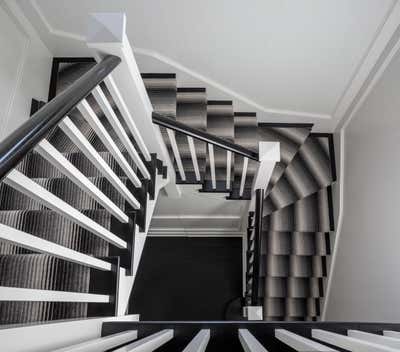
[326,44,400,322]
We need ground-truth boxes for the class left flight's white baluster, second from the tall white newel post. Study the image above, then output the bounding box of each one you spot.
[92,86,151,179]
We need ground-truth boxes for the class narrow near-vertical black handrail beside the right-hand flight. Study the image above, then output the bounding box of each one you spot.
[251,189,264,306]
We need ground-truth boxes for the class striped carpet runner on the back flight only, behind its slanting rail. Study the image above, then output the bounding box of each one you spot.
[142,73,258,199]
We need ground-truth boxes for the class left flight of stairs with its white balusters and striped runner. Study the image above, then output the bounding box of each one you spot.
[0,57,166,324]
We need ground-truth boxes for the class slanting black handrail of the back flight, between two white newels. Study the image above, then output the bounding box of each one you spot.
[153,112,259,161]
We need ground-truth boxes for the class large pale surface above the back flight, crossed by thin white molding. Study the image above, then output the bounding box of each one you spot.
[14,0,399,132]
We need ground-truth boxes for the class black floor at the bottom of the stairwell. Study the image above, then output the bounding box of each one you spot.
[129,237,242,321]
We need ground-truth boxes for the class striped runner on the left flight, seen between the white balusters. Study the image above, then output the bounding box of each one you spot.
[0,64,160,324]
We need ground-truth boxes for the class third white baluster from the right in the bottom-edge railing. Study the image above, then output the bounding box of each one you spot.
[311,329,398,352]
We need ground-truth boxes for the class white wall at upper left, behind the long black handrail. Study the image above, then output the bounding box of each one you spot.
[0,1,52,140]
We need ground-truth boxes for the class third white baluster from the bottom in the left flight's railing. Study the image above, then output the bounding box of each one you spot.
[3,169,127,248]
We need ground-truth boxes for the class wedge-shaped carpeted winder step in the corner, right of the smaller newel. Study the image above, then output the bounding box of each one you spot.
[266,135,335,212]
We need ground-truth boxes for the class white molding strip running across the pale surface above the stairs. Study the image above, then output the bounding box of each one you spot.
[31,0,400,129]
